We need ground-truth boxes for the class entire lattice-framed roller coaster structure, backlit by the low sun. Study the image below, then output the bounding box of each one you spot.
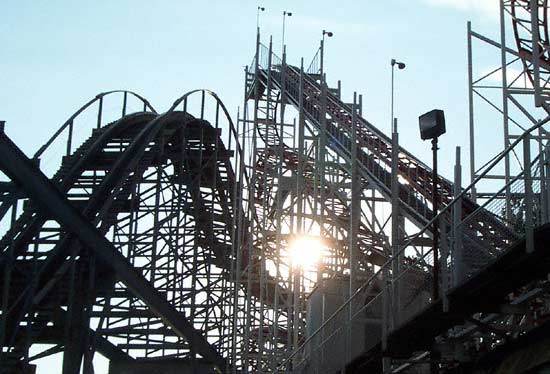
[0,0,550,374]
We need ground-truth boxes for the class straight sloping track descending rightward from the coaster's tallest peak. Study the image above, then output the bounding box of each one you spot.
[249,54,517,264]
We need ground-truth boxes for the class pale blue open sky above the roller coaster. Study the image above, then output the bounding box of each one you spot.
[0,0,528,374]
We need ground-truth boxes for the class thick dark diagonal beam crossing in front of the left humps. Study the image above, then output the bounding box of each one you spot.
[0,131,226,372]
